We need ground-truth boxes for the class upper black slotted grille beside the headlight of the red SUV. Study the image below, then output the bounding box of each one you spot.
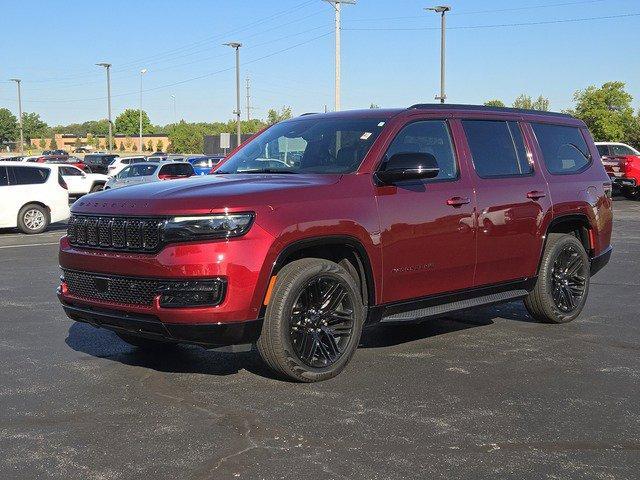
[67,215,164,252]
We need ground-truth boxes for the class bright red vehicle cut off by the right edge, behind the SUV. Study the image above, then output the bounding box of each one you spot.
[596,142,640,200]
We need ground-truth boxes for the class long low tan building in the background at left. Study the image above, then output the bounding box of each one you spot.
[31,133,169,152]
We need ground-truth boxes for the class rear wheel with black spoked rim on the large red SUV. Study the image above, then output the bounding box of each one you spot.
[524,233,590,323]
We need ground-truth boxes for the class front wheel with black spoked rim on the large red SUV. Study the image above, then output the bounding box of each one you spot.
[257,258,365,382]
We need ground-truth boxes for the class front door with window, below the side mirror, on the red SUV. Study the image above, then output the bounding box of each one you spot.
[376,119,475,303]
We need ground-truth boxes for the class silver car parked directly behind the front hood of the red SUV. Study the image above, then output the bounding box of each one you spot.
[104,161,195,190]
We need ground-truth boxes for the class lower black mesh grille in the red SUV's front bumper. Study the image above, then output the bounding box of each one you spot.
[64,270,165,306]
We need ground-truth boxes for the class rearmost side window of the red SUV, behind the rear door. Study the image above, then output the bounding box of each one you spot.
[531,123,591,175]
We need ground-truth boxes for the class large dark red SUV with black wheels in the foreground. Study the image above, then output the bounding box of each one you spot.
[58,105,612,382]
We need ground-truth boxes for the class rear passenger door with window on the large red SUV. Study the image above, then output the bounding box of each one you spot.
[461,117,552,286]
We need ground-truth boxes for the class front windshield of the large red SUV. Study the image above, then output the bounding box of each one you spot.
[216,115,385,174]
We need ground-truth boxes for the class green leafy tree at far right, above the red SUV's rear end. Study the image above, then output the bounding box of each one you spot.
[569,82,634,142]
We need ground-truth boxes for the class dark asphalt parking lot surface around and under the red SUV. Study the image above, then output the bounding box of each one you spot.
[0,198,640,479]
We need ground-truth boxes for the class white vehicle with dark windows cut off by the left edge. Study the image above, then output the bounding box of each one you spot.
[0,162,69,233]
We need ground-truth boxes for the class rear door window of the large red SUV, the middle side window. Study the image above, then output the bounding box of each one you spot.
[462,120,533,178]
